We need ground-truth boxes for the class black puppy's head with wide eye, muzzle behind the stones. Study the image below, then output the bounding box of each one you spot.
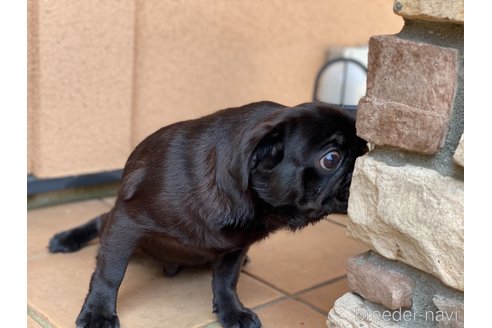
[242,103,367,228]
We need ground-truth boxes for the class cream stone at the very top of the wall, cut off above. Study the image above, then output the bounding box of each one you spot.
[393,0,465,24]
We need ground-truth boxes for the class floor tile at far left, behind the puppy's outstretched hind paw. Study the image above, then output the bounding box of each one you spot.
[27,200,110,259]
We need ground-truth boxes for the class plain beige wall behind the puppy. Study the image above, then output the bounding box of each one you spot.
[28,0,403,177]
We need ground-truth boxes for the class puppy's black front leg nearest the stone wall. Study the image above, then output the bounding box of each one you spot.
[212,249,261,328]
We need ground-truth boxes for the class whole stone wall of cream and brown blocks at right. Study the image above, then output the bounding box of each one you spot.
[327,0,464,327]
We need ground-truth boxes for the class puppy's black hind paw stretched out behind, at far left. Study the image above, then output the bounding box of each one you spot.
[48,213,107,253]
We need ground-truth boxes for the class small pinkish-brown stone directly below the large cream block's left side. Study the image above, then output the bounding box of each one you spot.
[347,253,415,310]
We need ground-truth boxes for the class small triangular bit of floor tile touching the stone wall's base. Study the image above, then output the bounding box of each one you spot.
[296,277,349,314]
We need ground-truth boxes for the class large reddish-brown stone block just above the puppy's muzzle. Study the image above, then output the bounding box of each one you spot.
[357,35,458,154]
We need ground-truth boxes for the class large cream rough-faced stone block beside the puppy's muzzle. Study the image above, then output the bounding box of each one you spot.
[347,155,464,290]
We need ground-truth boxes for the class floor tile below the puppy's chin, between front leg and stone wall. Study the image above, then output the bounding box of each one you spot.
[245,220,368,294]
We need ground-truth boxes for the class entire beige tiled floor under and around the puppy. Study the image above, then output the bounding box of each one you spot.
[27,199,367,328]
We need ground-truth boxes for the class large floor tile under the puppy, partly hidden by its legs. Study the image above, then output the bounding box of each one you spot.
[28,246,282,328]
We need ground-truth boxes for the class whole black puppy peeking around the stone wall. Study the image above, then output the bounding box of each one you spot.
[49,102,366,327]
